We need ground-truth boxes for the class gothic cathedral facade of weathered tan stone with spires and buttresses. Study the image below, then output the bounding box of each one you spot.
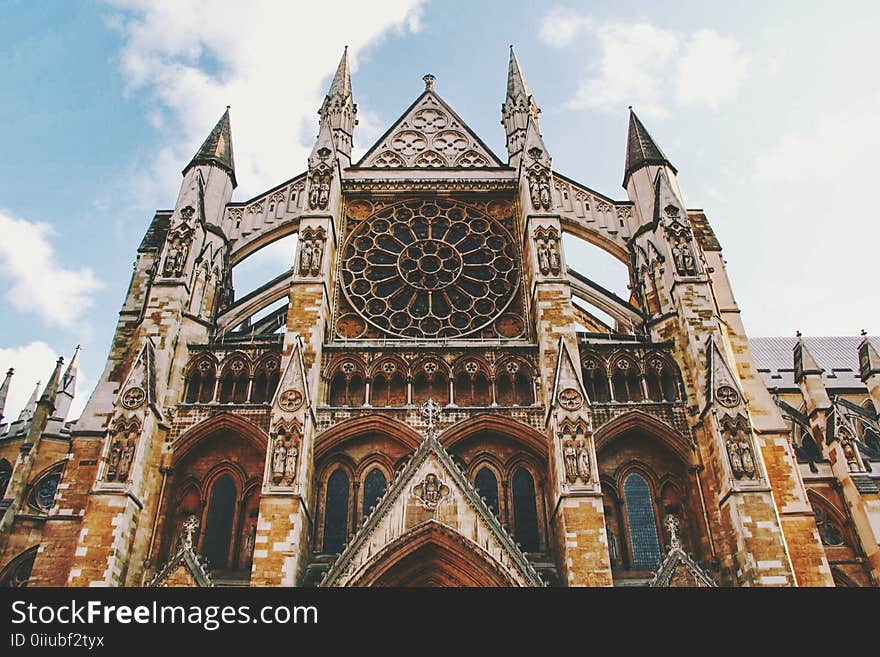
[0,49,880,586]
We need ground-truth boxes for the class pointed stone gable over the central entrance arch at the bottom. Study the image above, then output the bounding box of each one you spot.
[321,408,544,587]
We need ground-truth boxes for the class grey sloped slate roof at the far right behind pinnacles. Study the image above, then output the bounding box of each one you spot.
[749,335,880,390]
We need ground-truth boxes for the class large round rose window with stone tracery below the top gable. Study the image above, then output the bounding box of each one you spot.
[342,201,518,338]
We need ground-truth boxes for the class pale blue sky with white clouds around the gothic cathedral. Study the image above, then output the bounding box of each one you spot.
[0,0,880,418]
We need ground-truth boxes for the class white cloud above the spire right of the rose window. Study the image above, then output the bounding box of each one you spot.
[540,7,749,117]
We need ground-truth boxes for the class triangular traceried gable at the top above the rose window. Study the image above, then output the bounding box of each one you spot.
[357,83,504,169]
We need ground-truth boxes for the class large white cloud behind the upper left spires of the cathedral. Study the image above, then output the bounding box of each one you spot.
[108,0,423,207]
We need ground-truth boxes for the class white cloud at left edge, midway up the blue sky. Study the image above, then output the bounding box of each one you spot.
[0,210,103,327]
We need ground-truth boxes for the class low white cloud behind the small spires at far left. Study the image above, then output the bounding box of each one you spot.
[0,341,93,422]
